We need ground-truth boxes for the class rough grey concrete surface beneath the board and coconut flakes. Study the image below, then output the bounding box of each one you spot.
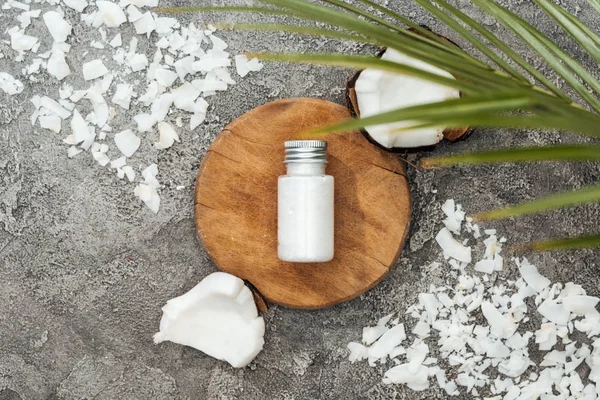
[0,0,600,399]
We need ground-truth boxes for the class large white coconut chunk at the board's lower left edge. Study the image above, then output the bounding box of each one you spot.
[154,272,265,368]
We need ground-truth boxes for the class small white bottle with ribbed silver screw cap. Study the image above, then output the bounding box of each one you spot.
[277,140,333,262]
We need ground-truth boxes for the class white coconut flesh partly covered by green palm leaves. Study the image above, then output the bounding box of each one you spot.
[354,49,460,148]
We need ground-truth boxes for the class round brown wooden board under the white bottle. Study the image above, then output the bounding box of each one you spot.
[194,98,411,308]
